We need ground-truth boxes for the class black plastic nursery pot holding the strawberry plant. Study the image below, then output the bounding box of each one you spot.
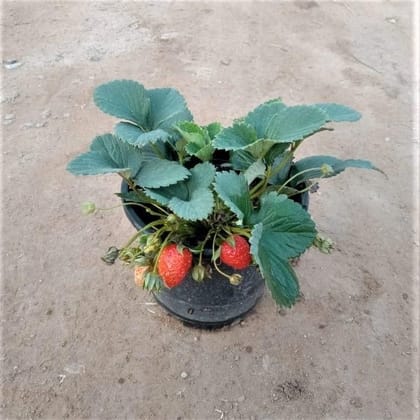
[121,181,309,328]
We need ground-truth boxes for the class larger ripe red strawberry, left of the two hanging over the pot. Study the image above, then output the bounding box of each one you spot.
[158,244,192,288]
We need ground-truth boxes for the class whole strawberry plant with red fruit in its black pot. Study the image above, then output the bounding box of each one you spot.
[67,80,376,326]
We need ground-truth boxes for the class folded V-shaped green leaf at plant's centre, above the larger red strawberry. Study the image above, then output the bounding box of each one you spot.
[145,162,216,221]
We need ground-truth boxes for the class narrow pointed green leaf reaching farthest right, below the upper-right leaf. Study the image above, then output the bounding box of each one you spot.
[292,155,382,181]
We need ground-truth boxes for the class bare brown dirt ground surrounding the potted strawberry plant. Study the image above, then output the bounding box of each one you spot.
[0,1,419,419]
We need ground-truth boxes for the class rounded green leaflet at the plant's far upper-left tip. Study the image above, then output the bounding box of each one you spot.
[93,80,151,126]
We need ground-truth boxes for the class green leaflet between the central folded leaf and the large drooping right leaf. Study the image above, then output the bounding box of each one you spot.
[214,171,252,224]
